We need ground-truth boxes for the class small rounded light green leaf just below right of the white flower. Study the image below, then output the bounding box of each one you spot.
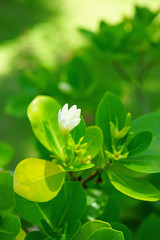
[82,126,103,159]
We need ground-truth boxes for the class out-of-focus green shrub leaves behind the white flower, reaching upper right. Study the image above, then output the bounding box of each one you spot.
[6,7,160,117]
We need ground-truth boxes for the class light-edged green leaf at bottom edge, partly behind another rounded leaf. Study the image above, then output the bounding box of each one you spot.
[73,220,111,240]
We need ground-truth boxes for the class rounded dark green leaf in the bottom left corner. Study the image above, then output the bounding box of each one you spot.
[0,215,21,240]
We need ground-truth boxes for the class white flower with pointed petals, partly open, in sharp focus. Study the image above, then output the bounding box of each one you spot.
[58,103,81,135]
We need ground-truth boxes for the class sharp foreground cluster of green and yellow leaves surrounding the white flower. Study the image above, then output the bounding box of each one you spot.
[0,92,160,240]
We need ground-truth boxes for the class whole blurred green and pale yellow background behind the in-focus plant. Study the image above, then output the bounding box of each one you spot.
[0,0,160,237]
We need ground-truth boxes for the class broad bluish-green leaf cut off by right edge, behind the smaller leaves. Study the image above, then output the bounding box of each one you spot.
[131,113,160,155]
